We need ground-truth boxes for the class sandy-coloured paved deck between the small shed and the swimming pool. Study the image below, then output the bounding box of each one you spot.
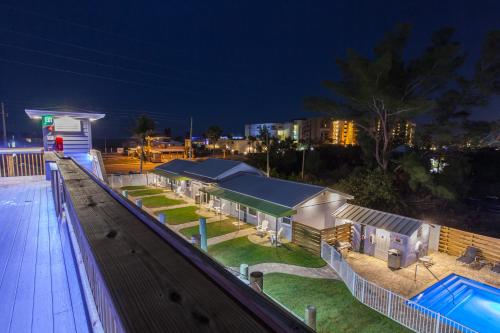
[347,252,500,298]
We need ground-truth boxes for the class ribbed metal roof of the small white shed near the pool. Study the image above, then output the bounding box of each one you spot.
[333,203,423,236]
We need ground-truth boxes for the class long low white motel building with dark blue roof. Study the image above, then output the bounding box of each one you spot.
[151,159,352,240]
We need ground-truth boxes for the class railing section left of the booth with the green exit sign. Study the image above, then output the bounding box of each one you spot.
[0,148,45,177]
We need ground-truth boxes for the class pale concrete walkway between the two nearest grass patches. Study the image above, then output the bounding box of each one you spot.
[230,263,340,280]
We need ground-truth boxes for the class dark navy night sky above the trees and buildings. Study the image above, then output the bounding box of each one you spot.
[0,0,500,138]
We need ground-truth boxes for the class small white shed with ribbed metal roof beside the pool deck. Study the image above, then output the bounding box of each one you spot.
[333,204,429,267]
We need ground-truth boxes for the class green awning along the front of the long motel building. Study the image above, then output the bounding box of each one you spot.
[200,187,296,217]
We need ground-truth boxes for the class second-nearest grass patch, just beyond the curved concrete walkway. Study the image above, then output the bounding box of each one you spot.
[208,237,325,267]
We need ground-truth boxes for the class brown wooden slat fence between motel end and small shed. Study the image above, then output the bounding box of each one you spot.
[292,222,352,256]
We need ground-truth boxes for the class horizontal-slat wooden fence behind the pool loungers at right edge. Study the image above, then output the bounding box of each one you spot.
[439,227,500,262]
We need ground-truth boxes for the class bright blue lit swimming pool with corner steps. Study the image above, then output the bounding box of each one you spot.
[411,274,500,333]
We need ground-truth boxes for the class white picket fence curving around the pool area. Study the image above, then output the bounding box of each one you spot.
[321,242,476,333]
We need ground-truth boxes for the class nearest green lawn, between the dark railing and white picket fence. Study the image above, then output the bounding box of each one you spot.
[264,273,411,333]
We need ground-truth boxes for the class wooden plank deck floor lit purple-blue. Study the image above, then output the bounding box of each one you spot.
[0,177,89,332]
